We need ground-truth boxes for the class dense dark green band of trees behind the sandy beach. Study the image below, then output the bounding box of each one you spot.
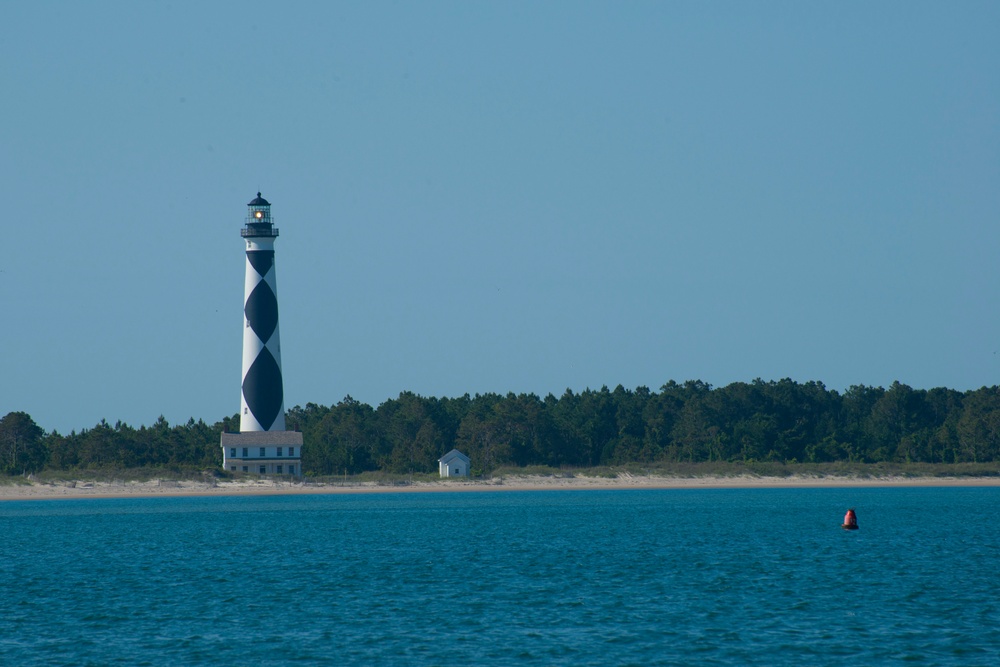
[0,379,1000,476]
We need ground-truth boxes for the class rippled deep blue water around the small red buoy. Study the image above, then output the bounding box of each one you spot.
[0,488,1000,666]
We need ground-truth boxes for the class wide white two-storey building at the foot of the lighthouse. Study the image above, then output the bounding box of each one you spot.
[220,431,302,477]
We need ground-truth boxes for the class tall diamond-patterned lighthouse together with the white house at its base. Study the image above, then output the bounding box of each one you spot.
[222,192,302,476]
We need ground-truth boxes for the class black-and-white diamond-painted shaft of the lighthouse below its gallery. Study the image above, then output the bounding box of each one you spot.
[240,248,285,431]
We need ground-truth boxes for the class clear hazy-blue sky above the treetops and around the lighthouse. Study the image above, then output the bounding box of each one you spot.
[0,0,1000,433]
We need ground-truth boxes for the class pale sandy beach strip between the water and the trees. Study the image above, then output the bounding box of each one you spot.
[0,475,1000,501]
